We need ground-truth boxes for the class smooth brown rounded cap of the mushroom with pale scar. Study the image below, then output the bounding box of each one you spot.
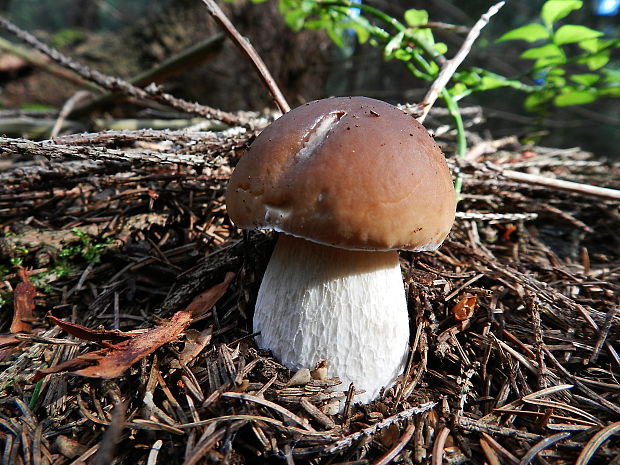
[226,97,456,250]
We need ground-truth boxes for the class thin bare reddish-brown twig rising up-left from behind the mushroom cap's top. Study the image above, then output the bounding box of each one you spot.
[202,0,291,113]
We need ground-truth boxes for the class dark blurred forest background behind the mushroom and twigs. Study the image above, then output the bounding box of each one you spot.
[0,0,620,158]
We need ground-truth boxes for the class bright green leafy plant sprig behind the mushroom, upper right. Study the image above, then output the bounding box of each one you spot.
[253,0,620,155]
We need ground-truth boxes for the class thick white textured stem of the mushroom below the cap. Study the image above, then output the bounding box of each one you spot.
[254,234,409,402]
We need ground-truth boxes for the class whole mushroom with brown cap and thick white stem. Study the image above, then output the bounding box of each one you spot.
[226,97,456,402]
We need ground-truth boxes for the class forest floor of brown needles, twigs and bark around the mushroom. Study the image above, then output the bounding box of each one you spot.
[0,102,620,465]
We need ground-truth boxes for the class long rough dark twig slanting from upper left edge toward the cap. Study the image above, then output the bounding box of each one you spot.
[0,16,239,125]
